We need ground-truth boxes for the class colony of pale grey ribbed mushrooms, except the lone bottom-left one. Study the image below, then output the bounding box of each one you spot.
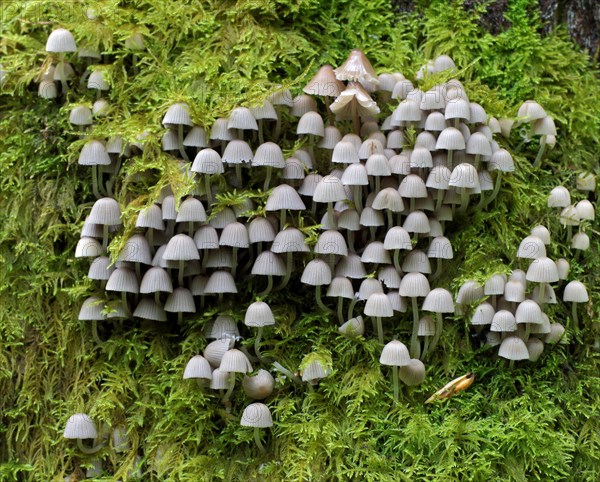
[40,29,593,458]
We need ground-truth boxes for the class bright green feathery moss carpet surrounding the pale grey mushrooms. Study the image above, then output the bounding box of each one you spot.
[0,0,600,482]
